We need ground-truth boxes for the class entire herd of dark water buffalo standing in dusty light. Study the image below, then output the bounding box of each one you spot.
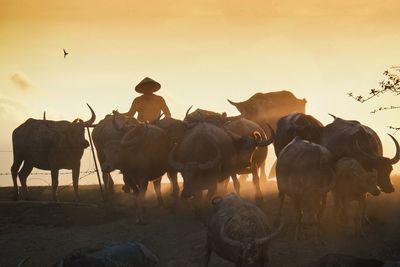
[11,91,400,266]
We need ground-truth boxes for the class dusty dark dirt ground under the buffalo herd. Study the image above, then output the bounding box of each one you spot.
[0,177,400,267]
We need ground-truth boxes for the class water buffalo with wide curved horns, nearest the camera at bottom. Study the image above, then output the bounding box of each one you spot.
[205,193,282,267]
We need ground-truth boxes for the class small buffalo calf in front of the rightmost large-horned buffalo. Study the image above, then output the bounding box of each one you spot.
[332,157,380,235]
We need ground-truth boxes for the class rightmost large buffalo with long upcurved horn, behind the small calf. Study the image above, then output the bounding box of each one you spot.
[320,116,400,193]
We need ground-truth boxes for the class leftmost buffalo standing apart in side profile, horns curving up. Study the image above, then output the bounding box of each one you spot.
[11,105,96,200]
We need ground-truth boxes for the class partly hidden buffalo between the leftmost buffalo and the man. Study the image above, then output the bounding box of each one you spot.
[92,113,139,196]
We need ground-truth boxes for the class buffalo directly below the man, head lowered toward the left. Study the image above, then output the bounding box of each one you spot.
[103,123,171,223]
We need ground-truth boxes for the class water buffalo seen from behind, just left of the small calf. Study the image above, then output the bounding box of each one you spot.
[276,137,334,242]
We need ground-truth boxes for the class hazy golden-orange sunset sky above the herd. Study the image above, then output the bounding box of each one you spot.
[0,0,400,186]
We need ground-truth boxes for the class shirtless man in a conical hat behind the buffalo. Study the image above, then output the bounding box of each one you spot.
[122,77,171,122]
